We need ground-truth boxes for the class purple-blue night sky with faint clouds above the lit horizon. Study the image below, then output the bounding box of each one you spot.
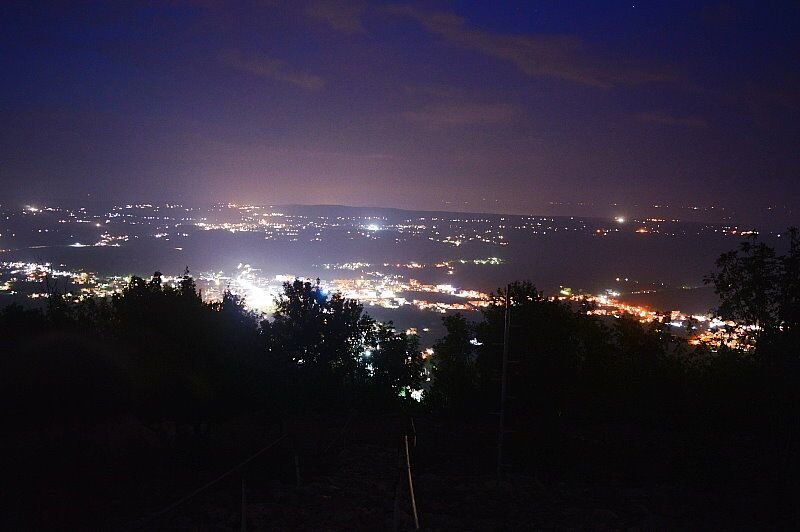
[0,0,800,223]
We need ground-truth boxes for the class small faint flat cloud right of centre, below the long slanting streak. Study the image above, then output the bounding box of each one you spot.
[404,102,519,129]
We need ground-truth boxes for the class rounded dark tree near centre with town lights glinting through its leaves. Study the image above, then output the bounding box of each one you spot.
[261,280,422,406]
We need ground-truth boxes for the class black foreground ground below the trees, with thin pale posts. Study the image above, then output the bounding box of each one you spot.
[2,410,797,530]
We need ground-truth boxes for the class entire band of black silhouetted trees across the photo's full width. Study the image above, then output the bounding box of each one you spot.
[0,235,800,525]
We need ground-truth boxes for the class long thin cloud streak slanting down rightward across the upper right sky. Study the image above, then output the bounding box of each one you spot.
[386,5,678,88]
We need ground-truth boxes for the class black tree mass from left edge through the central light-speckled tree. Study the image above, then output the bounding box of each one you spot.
[0,270,422,436]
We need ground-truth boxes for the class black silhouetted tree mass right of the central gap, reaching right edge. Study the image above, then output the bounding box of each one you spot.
[429,270,800,522]
